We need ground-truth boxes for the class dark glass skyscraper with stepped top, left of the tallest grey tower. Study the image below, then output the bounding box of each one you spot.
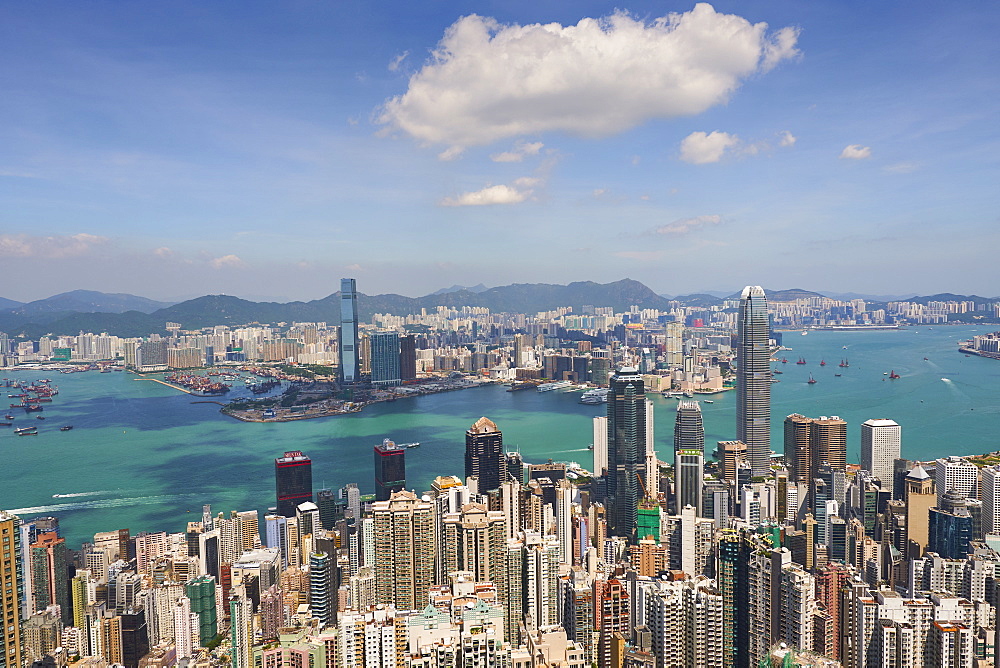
[607,367,646,538]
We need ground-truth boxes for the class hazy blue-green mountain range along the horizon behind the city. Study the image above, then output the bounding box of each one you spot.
[0,279,1000,339]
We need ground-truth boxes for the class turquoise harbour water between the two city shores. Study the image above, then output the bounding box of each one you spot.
[0,326,1000,546]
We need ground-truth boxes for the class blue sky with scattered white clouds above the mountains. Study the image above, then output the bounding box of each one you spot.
[0,0,1000,301]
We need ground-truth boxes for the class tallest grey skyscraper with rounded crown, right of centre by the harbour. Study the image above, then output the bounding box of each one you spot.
[736,285,771,476]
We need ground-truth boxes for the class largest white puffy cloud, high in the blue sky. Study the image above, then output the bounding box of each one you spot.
[377,3,798,146]
